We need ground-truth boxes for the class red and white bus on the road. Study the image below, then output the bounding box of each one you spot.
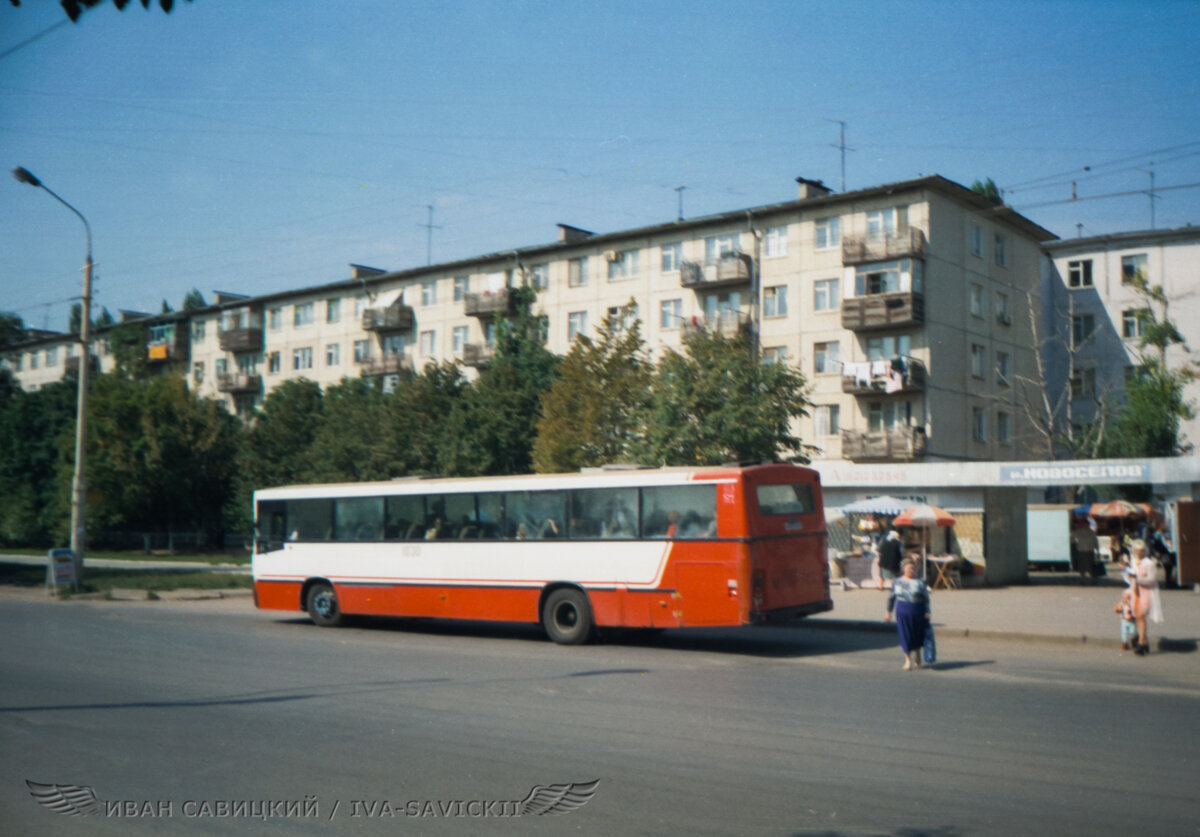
[253,465,833,644]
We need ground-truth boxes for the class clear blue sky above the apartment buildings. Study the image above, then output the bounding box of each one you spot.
[0,0,1200,330]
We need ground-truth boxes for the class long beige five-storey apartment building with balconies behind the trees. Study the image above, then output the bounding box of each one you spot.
[4,175,1056,462]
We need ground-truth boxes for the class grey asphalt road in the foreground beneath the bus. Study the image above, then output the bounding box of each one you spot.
[0,589,1200,837]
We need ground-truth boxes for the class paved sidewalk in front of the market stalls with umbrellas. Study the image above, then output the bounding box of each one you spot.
[805,573,1200,651]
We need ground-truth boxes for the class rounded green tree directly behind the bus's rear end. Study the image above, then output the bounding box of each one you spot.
[640,330,809,465]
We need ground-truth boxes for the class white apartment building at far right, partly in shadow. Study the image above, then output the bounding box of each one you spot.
[1043,227,1200,444]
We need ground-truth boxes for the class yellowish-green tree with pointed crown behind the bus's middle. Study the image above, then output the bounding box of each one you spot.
[533,302,654,474]
